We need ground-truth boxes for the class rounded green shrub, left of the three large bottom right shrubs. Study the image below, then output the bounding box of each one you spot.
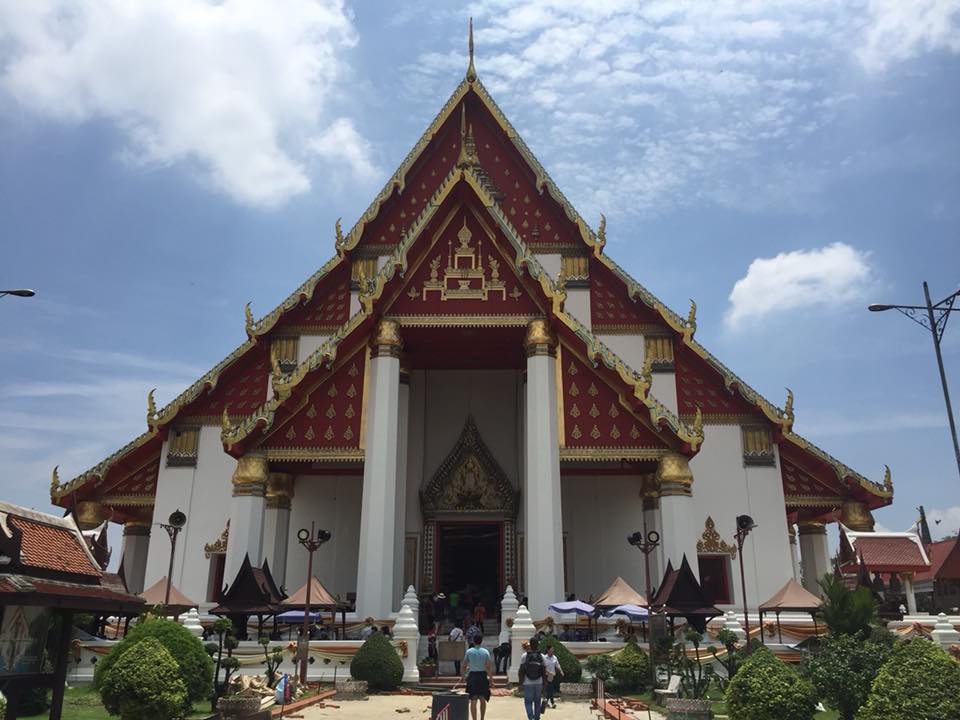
[726,647,817,720]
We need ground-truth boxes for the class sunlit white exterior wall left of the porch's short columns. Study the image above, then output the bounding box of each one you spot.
[144,426,237,602]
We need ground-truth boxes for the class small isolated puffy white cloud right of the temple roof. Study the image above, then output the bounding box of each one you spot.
[724,242,871,330]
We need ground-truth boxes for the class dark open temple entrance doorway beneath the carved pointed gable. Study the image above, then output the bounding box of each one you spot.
[437,521,505,631]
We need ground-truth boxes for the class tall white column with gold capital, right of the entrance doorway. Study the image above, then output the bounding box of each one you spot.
[523,320,563,617]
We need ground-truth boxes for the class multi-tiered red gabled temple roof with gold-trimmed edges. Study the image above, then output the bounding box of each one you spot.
[51,28,893,520]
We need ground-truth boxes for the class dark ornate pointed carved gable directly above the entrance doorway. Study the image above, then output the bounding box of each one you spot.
[420,416,520,518]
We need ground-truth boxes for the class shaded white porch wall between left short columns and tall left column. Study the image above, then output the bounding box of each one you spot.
[277,475,364,598]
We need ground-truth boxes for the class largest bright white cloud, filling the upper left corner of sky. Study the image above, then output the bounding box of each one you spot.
[0,0,373,207]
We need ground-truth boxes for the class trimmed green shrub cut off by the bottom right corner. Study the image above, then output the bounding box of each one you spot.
[857,638,960,720]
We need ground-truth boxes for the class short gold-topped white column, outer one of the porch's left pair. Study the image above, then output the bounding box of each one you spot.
[223,453,270,585]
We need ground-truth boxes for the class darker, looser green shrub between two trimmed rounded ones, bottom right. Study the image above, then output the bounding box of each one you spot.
[803,635,891,720]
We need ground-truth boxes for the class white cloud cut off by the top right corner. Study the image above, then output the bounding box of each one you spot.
[857,0,960,72]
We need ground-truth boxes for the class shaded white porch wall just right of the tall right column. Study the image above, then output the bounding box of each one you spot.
[561,475,648,601]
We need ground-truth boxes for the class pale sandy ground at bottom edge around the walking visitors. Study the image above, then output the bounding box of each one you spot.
[296,695,663,720]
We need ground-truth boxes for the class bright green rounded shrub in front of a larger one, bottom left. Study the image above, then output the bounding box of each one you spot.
[100,637,190,720]
